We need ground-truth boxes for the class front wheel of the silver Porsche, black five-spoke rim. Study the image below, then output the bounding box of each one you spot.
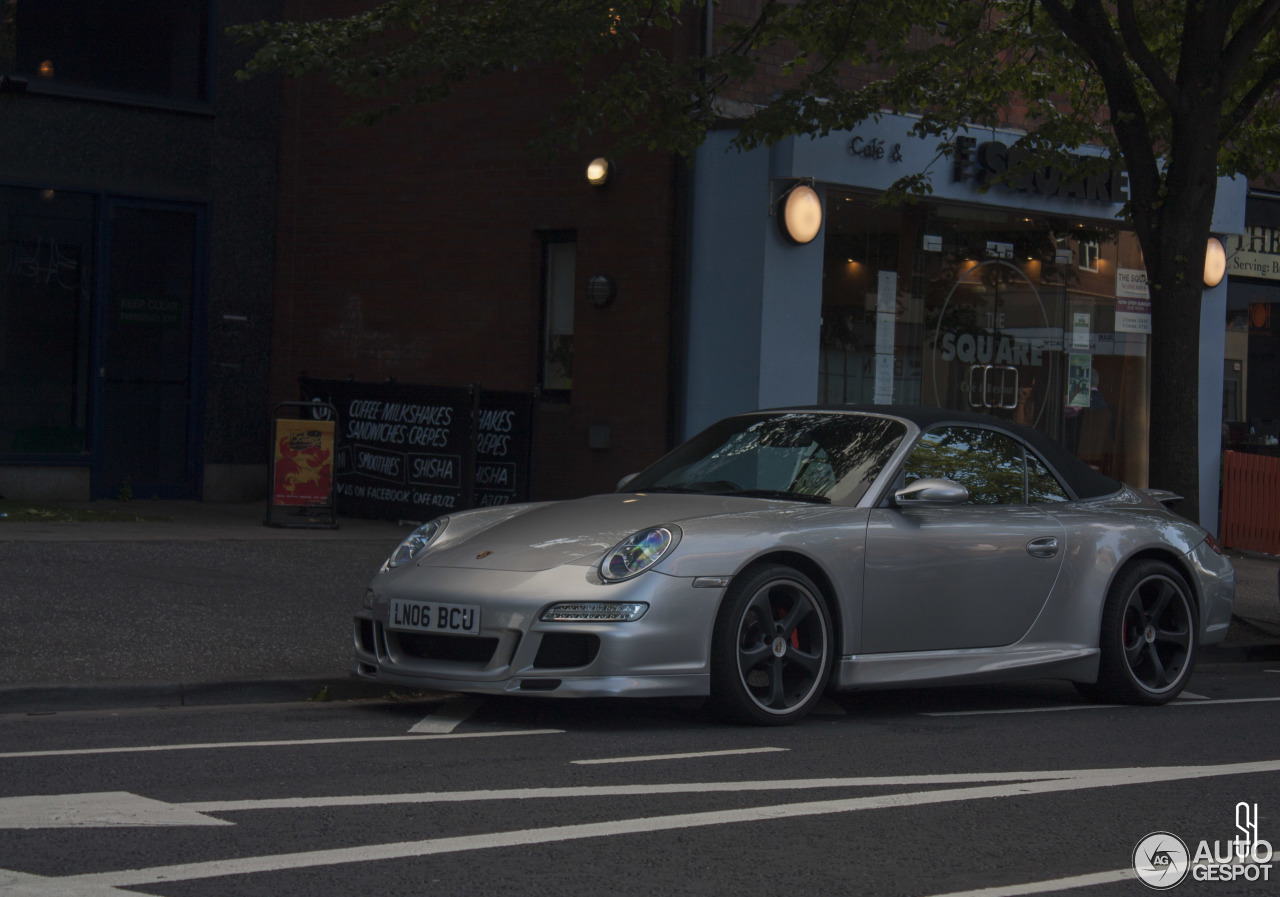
[710,564,835,726]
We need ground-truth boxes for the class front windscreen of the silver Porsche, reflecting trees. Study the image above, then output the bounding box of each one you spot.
[625,412,906,504]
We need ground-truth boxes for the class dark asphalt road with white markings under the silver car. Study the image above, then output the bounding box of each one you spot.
[0,664,1280,897]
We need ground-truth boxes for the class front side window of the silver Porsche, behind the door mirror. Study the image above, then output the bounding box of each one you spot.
[905,426,1024,504]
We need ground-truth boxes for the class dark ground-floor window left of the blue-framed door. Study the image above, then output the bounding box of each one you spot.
[0,187,93,457]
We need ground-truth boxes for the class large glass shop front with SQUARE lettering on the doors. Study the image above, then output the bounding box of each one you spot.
[818,189,1157,483]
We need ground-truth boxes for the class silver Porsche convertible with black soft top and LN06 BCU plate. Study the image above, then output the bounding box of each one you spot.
[352,406,1234,724]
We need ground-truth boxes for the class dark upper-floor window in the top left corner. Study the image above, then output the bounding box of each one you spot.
[0,0,209,102]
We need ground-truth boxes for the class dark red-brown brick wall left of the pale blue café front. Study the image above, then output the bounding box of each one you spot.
[271,4,677,498]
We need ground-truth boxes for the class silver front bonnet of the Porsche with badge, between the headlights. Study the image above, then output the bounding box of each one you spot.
[417,493,795,572]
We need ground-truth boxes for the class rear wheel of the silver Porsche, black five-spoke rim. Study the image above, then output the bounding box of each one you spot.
[1076,559,1199,705]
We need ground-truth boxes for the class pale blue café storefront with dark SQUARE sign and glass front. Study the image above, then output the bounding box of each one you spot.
[684,115,1243,516]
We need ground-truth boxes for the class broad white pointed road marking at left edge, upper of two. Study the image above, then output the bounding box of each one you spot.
[0,791,227,829]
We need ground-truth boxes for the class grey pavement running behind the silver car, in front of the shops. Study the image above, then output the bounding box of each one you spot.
[0,502,1280,713]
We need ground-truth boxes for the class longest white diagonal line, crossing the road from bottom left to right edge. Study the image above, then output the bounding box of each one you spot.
[0,760,1280,897]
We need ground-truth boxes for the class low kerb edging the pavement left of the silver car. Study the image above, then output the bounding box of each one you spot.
[0,676,404,714]
